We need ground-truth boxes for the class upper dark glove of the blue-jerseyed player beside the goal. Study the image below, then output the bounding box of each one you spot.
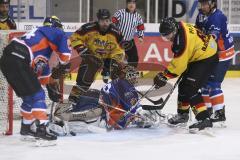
[52,63,71,79]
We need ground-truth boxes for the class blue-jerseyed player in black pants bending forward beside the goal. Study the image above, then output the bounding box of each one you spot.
[0,16,71,140]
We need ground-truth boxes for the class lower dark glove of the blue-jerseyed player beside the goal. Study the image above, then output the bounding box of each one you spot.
[46,82,62,102]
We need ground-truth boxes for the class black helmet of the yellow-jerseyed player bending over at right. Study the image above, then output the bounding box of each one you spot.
[159,17,177,36]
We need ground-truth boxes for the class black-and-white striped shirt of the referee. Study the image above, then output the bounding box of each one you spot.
[112,9,144,41]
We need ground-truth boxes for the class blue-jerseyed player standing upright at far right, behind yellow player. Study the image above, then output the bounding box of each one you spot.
[196,0,234,122]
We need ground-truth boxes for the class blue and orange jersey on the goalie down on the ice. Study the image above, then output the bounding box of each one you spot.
[100,79,140,129]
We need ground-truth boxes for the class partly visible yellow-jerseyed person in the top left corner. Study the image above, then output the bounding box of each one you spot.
[0,0,16,30]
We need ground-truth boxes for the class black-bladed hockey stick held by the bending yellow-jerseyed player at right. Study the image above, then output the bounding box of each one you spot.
[142,74,183,110]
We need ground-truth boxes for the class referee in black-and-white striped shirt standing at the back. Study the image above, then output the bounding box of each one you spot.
[112,0,144,68]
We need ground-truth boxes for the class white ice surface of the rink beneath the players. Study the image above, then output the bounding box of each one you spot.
[0,78,240,160]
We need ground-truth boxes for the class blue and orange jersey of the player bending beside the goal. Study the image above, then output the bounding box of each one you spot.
[21,26,71,84]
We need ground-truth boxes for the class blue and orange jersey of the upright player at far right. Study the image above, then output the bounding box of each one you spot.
[196,9,234,61]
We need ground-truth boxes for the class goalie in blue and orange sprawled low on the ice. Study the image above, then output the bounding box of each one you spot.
[55,66,158,132]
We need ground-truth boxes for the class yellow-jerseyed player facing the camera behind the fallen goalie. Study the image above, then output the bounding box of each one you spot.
[69,9,125,104]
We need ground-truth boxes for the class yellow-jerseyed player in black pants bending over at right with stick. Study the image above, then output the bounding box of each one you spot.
[154,18,219,132]
